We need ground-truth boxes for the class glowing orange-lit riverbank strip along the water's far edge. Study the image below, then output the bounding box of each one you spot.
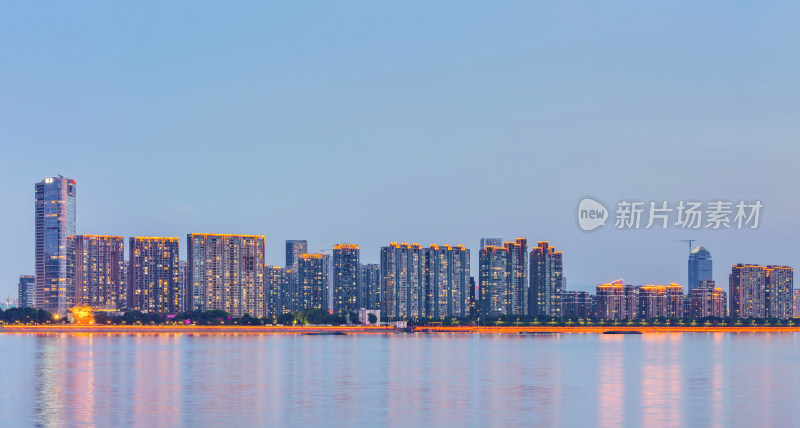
[0,324,800,335]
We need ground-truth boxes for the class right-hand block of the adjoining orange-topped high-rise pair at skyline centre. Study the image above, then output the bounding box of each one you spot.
[422,245,469,319]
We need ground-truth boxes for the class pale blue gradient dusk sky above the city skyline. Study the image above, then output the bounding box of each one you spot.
[0,1,800,301]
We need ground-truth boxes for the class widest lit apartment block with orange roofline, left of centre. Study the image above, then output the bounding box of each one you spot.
[187,233,264,317]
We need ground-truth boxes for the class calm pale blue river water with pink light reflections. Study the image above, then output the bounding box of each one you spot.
[0,333,800,428]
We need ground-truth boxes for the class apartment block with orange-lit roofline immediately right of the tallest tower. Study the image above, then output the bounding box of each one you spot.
[67,235,125,308]
